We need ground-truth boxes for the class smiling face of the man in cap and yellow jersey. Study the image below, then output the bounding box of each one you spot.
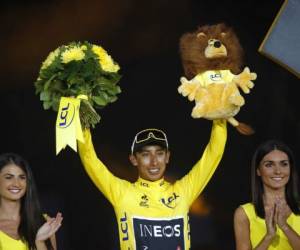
[130,145,170,181]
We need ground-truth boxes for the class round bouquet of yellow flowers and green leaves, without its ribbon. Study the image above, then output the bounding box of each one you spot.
[35,41,121,128]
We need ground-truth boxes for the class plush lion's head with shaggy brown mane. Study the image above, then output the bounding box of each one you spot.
[180,24,243,78]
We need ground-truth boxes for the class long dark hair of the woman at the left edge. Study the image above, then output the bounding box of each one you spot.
[0,153,53,250]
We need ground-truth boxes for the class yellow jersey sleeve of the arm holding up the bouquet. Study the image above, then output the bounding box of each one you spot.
[78,129,129,205]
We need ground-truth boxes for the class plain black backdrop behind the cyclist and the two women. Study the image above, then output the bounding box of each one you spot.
[0,0,300,250]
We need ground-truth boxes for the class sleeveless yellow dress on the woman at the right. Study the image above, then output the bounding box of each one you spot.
[242,203,300,250]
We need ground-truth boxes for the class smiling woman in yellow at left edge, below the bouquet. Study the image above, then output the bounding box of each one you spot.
[0,153,62,250]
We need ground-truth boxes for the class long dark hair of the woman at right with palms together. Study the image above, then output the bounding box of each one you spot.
[251,140,300,218]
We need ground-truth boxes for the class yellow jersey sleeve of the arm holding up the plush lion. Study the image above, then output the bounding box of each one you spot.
[175,120,227,205]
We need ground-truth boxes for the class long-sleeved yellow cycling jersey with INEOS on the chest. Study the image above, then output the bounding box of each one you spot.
[79,120,227,250]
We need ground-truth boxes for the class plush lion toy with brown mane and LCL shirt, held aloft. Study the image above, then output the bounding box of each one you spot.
[178,23,256,135]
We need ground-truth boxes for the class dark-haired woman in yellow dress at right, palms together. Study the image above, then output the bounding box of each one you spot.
[234,140,300,250]
